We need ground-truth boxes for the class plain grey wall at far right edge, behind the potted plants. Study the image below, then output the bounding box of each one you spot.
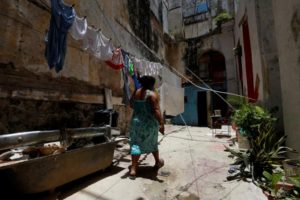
[273,0,300,152]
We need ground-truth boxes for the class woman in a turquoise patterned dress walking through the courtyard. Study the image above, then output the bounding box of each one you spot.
[130,76,164,177]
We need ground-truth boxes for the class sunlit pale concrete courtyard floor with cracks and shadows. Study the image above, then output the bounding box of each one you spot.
[30,125,266,200]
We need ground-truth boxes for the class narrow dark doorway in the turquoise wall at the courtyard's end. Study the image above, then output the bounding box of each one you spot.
[197,92,208,127]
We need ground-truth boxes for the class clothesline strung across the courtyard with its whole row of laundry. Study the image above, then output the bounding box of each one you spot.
[45,0,251,114]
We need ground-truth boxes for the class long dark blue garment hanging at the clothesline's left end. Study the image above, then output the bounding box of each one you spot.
[45,0,75,72]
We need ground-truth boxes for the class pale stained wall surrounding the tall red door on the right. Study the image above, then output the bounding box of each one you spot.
[235,0,283,130]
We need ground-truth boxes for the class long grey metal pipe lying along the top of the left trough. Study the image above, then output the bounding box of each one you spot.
[0,126,111,150]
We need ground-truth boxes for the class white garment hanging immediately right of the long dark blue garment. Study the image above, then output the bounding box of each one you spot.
[69,16,88,40]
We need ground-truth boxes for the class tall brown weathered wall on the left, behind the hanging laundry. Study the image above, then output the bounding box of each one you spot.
[0,0,173,133]
